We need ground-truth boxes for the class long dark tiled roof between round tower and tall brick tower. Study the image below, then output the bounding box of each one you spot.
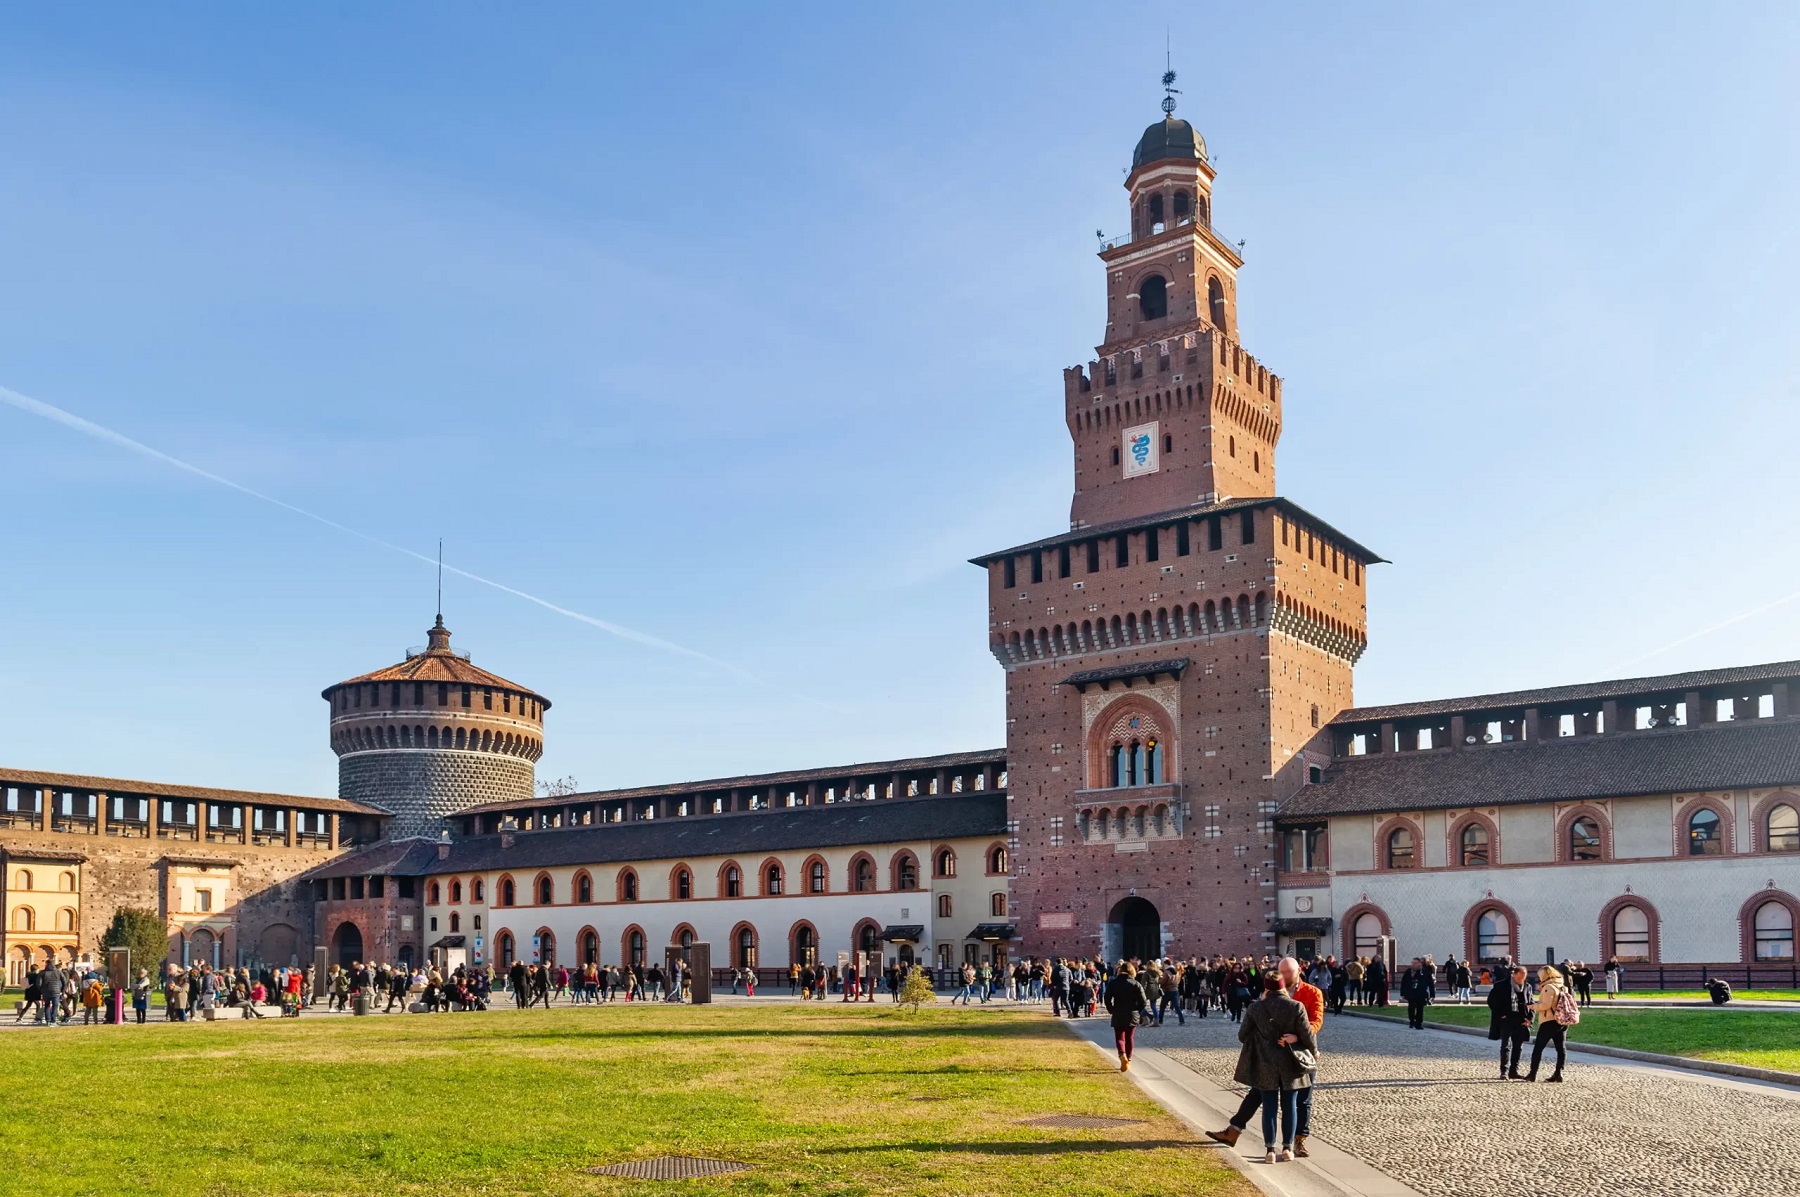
[308,792,1006,878]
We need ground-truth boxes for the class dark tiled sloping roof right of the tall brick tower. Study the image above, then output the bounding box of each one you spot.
[1280,720,1800,819]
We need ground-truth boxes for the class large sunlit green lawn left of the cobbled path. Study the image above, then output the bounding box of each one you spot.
[0,1004,1255,1197]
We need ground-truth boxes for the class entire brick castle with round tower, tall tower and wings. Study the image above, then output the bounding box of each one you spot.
[0,93,1800,983]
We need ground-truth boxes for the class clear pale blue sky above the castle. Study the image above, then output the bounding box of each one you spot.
[0,4,1800,794]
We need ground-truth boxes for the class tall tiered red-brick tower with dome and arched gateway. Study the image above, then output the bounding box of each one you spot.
[976,77,1381,958]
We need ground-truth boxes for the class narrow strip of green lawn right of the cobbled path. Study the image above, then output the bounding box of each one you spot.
[1370,1004,1800,1073]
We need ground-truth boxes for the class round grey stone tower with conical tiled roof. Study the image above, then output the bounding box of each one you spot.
[322,616,551,839]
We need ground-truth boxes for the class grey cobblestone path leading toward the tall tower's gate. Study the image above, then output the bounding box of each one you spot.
[1138,1017,1800,1197]
